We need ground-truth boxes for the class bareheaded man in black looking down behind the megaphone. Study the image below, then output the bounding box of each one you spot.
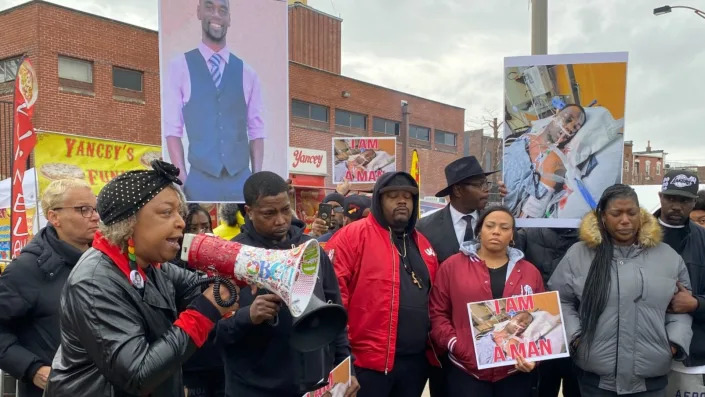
[216,171,359,397]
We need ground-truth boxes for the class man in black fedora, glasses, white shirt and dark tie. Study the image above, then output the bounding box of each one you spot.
[416,156,506,263]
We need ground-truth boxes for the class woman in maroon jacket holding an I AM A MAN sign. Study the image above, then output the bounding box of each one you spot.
[429,207,544,397]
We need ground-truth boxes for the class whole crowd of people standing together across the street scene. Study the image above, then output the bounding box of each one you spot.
[0,156,705,397]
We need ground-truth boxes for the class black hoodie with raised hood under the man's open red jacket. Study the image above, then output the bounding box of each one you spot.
[372,172,431,359]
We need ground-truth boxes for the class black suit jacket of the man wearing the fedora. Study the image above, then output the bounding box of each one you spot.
[416,204,460,264]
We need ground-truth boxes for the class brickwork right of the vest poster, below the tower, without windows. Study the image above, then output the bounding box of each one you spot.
[289,62,465,196]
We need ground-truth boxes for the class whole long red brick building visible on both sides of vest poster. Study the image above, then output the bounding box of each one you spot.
[0,0,468,195]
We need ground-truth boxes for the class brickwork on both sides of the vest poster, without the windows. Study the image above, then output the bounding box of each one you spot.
[0,1,465,195]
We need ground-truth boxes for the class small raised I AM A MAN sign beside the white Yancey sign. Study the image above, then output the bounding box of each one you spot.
[333,137,397,184]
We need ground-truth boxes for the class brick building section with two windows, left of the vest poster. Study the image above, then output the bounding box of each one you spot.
[0,0,161,178]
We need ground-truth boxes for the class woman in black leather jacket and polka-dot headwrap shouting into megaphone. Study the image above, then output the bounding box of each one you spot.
[45,160,238,397]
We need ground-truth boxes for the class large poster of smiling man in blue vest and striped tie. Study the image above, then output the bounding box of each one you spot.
[159,0,289,202]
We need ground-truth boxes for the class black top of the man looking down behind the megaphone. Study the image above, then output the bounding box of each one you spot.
[216,219,350,397]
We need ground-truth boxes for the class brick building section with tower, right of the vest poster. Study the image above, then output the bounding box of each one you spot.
[289,2,466,196]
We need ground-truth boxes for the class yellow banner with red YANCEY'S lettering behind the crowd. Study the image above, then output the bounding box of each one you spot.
[34,132,162,197]
